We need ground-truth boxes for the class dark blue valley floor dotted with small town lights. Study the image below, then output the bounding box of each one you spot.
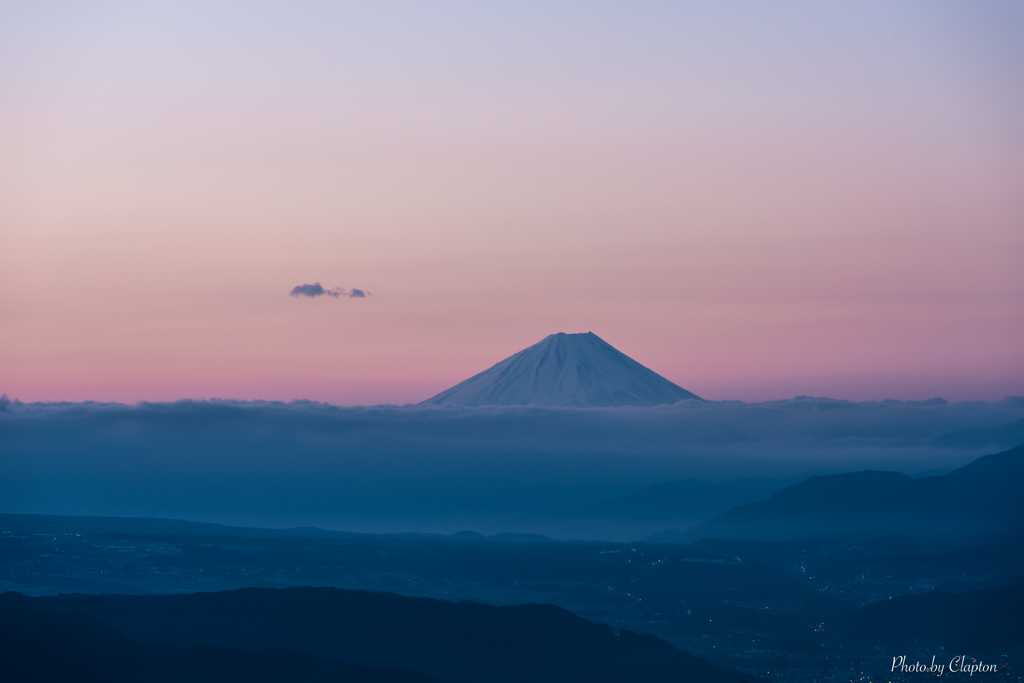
[0,516,1024,681]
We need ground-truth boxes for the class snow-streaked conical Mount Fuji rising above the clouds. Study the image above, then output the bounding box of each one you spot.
[422,332,701,408]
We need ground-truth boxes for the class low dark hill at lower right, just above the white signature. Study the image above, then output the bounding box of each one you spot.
[838,585,1024,653]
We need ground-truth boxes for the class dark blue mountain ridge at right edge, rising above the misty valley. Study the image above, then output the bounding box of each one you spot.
[648,445,1024,543]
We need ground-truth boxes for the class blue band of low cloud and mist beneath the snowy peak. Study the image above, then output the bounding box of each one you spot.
[0,397,1024,532]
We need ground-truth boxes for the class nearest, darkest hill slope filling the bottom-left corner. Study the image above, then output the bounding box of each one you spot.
[0,593,437,683]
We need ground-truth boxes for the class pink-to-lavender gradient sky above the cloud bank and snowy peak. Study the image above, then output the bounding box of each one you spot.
[0,0,1024,404]
